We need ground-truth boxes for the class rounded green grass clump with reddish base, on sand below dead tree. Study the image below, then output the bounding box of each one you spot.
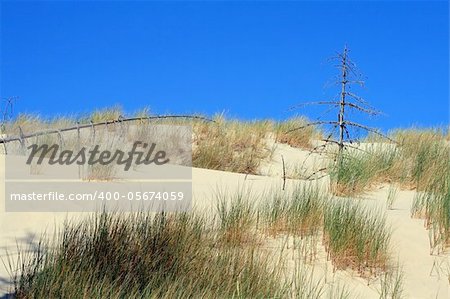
[323,200,390,276]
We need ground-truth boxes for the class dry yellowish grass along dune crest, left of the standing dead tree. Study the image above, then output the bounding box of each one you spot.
[0,106,319,174]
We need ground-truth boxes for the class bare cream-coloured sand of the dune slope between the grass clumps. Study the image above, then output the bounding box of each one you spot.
[0,145,450,298]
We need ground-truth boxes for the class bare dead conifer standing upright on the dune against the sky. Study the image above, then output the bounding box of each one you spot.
[287,46,395,179]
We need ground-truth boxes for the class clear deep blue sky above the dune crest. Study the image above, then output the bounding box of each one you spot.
[0,1,449,129]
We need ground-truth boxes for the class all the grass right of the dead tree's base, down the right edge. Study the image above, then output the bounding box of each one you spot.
[330,129,450,251]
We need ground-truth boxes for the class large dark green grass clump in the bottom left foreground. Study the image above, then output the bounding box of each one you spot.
[14,213,285,298]
